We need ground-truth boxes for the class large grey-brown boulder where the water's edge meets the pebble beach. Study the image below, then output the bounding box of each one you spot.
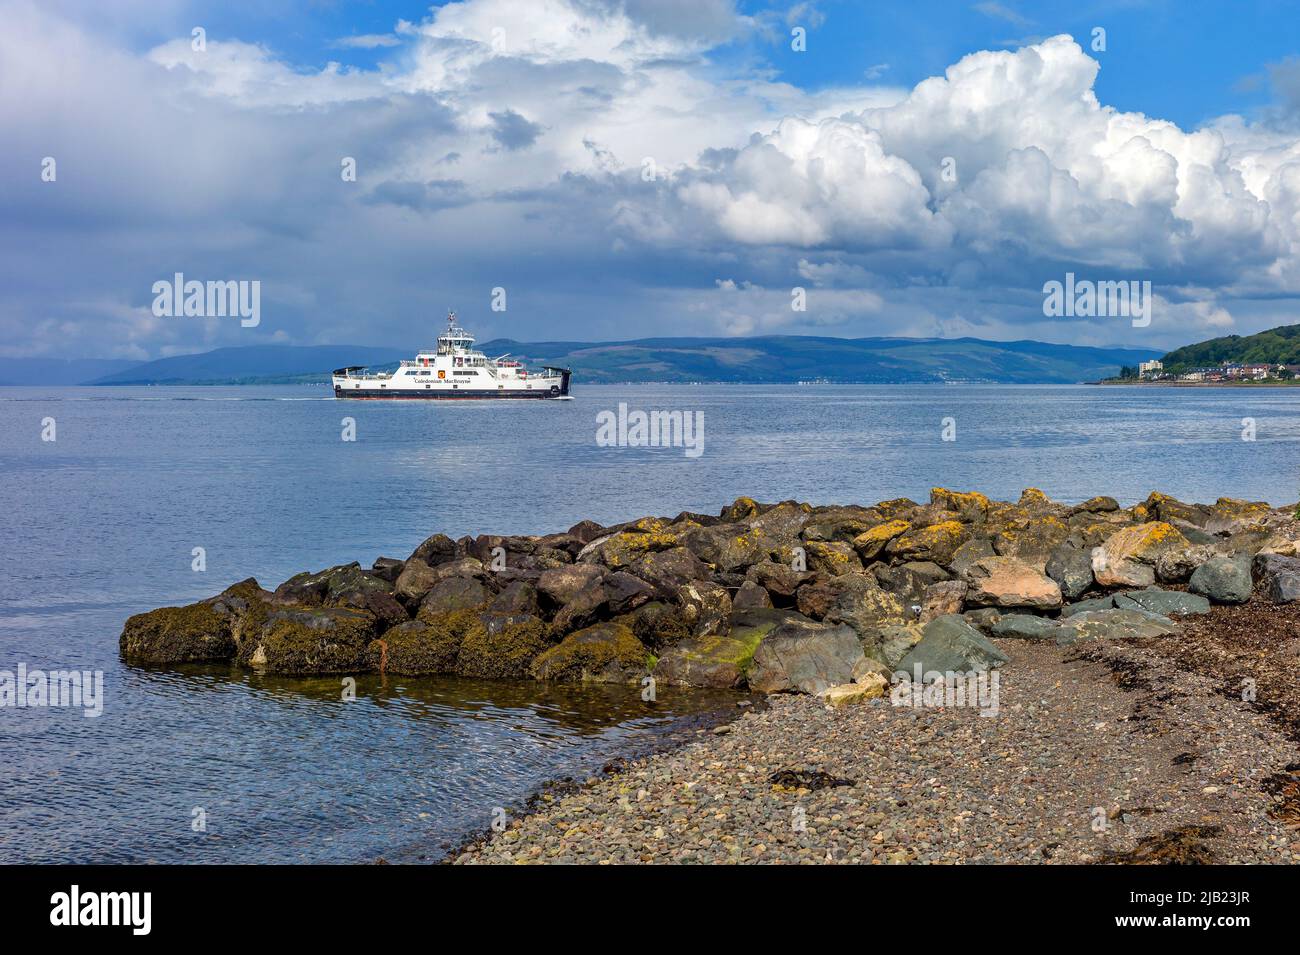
[749,622,870,694]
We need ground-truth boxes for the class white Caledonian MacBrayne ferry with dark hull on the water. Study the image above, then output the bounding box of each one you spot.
[333,312,569,400]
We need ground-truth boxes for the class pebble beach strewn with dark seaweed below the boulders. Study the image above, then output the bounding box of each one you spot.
[445,605,1300,865]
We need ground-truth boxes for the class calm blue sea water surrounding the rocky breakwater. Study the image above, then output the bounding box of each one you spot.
[0,382,1300,861]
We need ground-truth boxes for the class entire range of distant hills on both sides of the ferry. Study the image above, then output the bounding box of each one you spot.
[0,335,1157,385]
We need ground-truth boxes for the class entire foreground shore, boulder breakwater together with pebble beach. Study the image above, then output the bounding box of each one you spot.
[120,487,1300,864]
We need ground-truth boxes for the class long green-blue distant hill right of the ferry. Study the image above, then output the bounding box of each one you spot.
[482,335,1158,383]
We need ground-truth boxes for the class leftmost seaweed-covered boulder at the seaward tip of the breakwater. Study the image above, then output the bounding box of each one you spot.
[118,577,270,664]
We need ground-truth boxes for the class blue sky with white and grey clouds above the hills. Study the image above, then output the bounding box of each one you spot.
[0,0,1300,360]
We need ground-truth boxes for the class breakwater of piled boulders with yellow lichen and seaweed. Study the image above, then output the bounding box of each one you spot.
[121,489,1300,704]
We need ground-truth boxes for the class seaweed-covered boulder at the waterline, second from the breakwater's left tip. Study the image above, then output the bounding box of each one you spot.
[239,607,376,674]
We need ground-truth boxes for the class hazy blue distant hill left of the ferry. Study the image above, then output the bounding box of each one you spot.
[92,344,411,385]
